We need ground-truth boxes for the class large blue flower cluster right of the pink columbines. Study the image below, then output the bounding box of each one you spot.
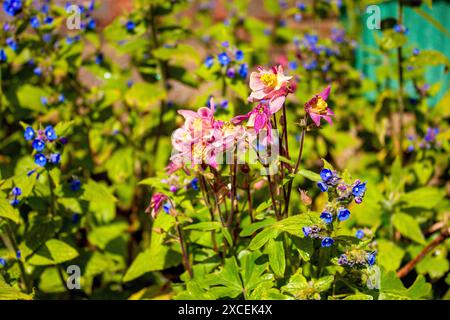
[303,169,366,247]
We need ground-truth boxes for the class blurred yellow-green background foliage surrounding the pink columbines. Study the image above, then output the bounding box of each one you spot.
[0,0,450,299]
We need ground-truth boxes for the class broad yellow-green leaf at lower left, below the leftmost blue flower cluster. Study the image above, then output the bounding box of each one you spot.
[28,239,78,266]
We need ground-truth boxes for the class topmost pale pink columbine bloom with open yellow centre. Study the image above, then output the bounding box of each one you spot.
[248,65,292,114]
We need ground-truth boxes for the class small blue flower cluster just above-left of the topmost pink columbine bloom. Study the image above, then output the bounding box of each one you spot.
[204,41,248,78]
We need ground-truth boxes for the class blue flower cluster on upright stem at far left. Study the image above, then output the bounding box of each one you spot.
[24,126,67,170]
